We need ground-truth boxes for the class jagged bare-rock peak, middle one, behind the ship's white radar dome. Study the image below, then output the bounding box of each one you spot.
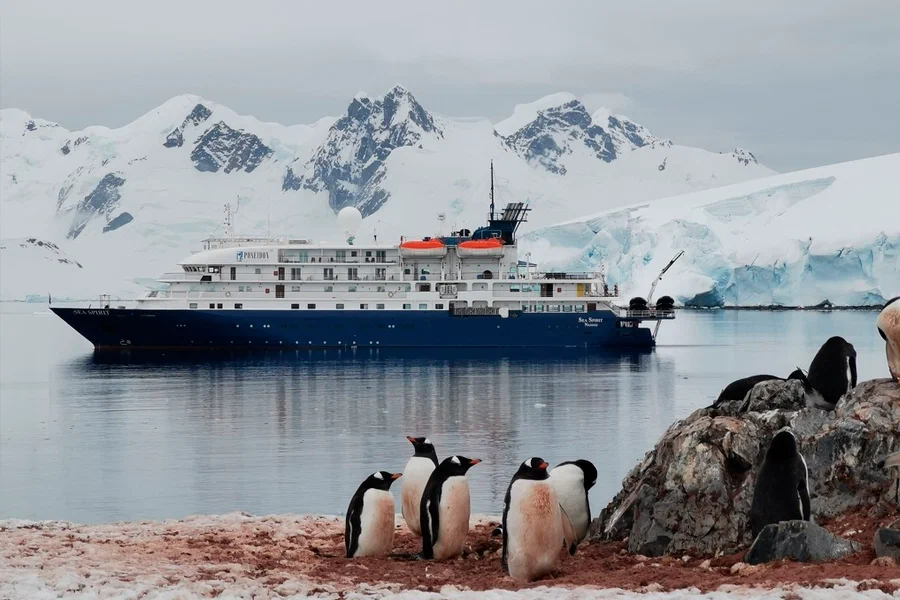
[282,85,443,216]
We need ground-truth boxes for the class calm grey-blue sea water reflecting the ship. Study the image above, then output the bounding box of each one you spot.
[0,303,886,523]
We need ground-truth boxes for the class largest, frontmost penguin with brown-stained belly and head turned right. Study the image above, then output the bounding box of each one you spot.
[502,456,576,581]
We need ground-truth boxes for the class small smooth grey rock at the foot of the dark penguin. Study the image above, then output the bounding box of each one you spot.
[744,521,859,565]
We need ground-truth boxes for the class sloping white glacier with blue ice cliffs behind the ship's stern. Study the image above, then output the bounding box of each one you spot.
[522,154,900,306]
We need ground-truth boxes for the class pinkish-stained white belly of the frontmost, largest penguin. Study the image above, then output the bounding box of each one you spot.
[506,479,563,581]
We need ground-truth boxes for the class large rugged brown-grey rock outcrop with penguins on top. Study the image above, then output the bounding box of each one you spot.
[591,379,900,556]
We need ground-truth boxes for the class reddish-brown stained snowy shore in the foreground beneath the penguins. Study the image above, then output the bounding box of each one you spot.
[0,513,900,600]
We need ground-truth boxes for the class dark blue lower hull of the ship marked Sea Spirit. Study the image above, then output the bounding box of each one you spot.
[51,307,654,350]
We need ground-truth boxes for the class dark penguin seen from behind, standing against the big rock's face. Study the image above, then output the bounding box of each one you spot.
[750,430,810,539]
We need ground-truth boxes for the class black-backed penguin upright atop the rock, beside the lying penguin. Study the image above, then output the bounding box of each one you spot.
[806,336,856,410]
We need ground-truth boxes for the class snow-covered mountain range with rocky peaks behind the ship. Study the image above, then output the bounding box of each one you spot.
[0,86,772,298]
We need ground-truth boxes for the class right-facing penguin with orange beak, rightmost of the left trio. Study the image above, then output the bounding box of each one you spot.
[419,456,481,560]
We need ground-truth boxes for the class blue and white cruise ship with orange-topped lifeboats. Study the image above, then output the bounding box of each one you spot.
[51,195,675,351]
